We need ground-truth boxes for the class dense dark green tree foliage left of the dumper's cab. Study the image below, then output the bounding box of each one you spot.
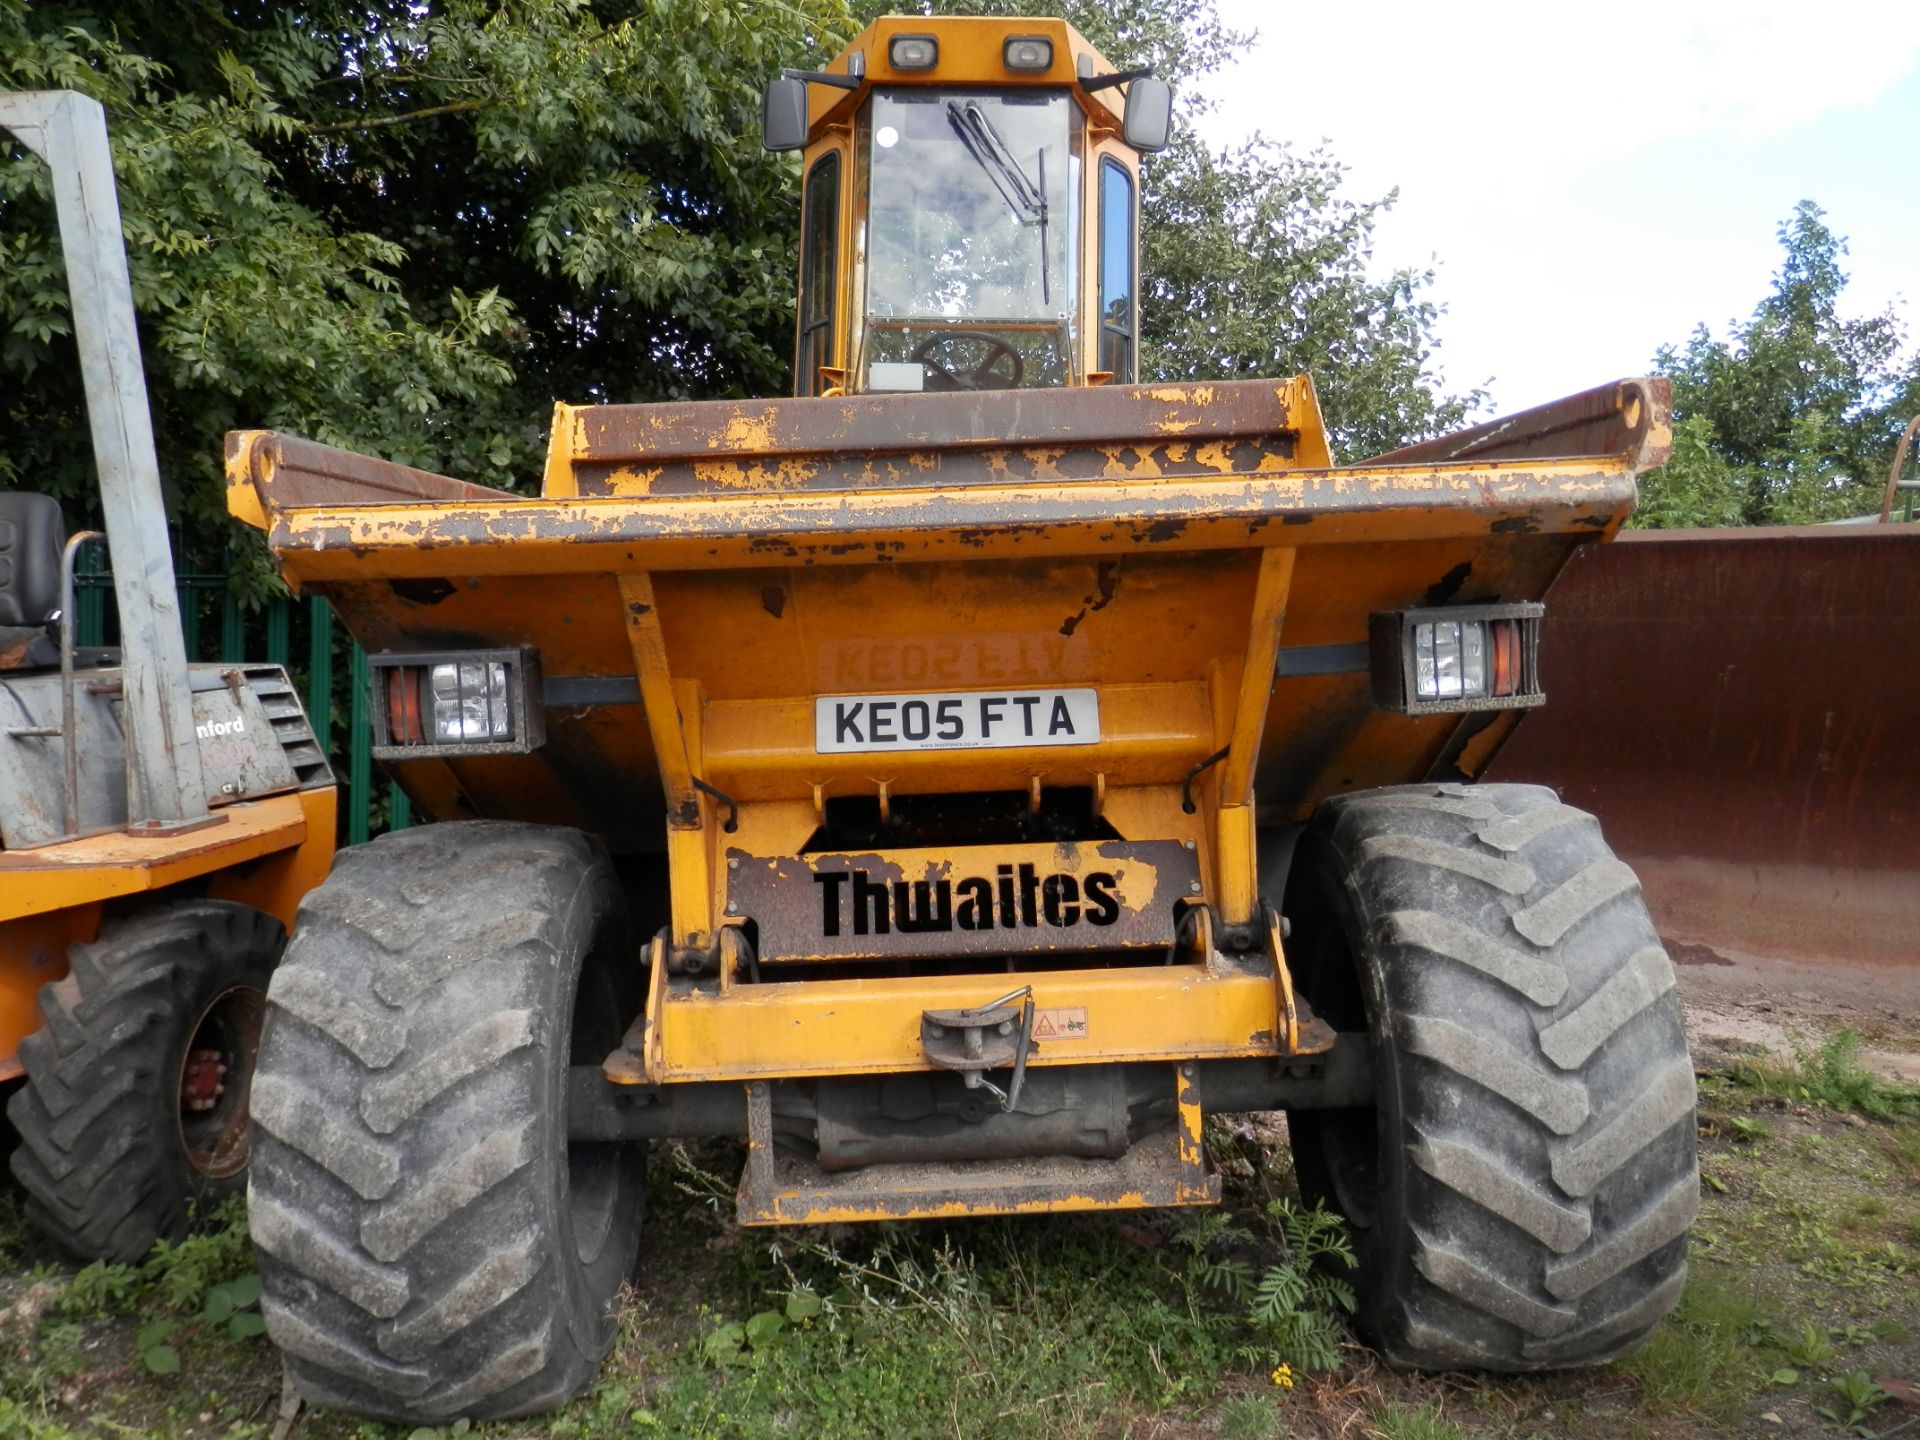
[0,0,849,584]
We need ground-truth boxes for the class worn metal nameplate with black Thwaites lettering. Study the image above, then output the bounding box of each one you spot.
[728,841,1200,962]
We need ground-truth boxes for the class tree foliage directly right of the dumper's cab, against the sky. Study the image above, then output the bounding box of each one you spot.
[879,0,1480,457]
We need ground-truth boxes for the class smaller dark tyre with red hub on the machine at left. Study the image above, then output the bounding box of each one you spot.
[8,900,282,1261]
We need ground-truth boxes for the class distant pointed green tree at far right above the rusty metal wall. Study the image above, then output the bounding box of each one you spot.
[1634,200,1920,528]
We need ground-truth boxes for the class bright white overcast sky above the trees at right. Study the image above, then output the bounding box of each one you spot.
[1202,0,1920,413]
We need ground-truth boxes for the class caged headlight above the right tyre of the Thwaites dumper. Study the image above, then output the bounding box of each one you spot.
[1371,605,1546,714]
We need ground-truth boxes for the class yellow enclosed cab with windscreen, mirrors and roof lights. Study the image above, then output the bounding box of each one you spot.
[764,19,1171,396]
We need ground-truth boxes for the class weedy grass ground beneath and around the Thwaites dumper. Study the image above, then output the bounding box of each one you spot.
[0,1056,1920,1440]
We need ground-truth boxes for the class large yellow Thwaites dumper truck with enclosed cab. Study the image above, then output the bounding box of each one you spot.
[228,17,1697,1421]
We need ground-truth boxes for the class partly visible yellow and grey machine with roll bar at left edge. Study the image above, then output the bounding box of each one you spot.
[0,90,334,1261]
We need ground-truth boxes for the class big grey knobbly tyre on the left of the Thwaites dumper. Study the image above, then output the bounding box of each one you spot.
[248,822,645,1423]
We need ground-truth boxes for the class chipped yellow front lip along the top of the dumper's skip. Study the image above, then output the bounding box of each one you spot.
[243,457,1634,584]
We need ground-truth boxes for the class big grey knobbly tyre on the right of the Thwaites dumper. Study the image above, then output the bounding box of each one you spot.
[1286,785,1699,1371]
